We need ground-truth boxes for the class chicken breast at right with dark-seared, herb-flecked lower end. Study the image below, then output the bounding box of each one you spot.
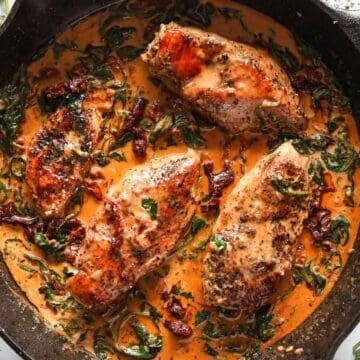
[204,143,310,311]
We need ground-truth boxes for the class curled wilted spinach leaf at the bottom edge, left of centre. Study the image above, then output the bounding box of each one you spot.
[115,321,163,359]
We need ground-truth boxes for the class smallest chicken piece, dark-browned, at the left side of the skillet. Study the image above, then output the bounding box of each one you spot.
[26,107,102,218]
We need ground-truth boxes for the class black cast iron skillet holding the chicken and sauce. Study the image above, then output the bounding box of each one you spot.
[0,0,360,360]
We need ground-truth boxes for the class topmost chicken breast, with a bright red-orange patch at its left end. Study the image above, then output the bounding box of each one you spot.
[142,23,306,135]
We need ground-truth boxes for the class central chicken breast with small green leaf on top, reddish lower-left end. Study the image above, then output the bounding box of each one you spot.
[66,151,200,309]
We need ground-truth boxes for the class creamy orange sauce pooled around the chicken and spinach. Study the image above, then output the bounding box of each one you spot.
[0,0,360,360]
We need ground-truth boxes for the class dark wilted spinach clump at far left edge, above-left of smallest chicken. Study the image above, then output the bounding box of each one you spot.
[0,66,28,156]
